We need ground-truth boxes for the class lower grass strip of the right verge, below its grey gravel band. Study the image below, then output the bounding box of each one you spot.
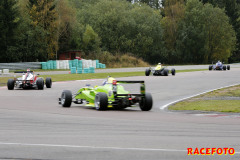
[168,100,240,113]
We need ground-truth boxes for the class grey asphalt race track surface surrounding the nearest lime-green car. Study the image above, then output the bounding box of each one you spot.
[0,68,240,160]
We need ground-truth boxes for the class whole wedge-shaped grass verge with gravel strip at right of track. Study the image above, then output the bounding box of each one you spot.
[168,85,240,113]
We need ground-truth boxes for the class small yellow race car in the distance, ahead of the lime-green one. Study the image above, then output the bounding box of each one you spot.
[145,63,176,76]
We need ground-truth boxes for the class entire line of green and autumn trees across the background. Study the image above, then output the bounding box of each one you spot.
[0,0,240,64]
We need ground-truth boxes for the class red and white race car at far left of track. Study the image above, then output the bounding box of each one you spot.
[7,69,52,90]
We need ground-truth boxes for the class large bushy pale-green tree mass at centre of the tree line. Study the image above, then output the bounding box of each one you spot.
[77,0,162,61]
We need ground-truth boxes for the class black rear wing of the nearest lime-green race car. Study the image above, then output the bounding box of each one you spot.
[112,80,145,97]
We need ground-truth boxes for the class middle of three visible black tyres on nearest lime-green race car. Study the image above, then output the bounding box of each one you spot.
[94,92,108,111]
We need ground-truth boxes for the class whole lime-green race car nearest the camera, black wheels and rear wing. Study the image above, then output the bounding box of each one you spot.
[59,77,152,111]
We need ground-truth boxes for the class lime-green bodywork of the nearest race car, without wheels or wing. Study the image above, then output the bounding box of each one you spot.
[75,84,129,106]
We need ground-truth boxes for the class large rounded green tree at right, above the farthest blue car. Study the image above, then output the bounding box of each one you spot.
[162,0,236,64]
